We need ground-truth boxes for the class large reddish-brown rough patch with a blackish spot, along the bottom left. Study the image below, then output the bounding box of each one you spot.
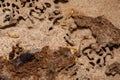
[0,46,75,80]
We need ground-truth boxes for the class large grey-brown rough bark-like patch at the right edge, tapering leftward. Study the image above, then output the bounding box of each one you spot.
[72,14,120,53]
